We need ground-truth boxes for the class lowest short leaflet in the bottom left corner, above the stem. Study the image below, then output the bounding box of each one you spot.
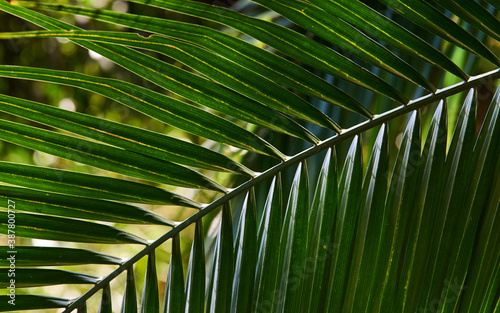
[0,295,71,312]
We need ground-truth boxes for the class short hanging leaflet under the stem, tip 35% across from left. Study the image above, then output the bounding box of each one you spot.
[163,235,186,313]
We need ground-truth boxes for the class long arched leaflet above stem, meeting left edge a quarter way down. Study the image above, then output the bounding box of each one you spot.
[0,65,284,159]
